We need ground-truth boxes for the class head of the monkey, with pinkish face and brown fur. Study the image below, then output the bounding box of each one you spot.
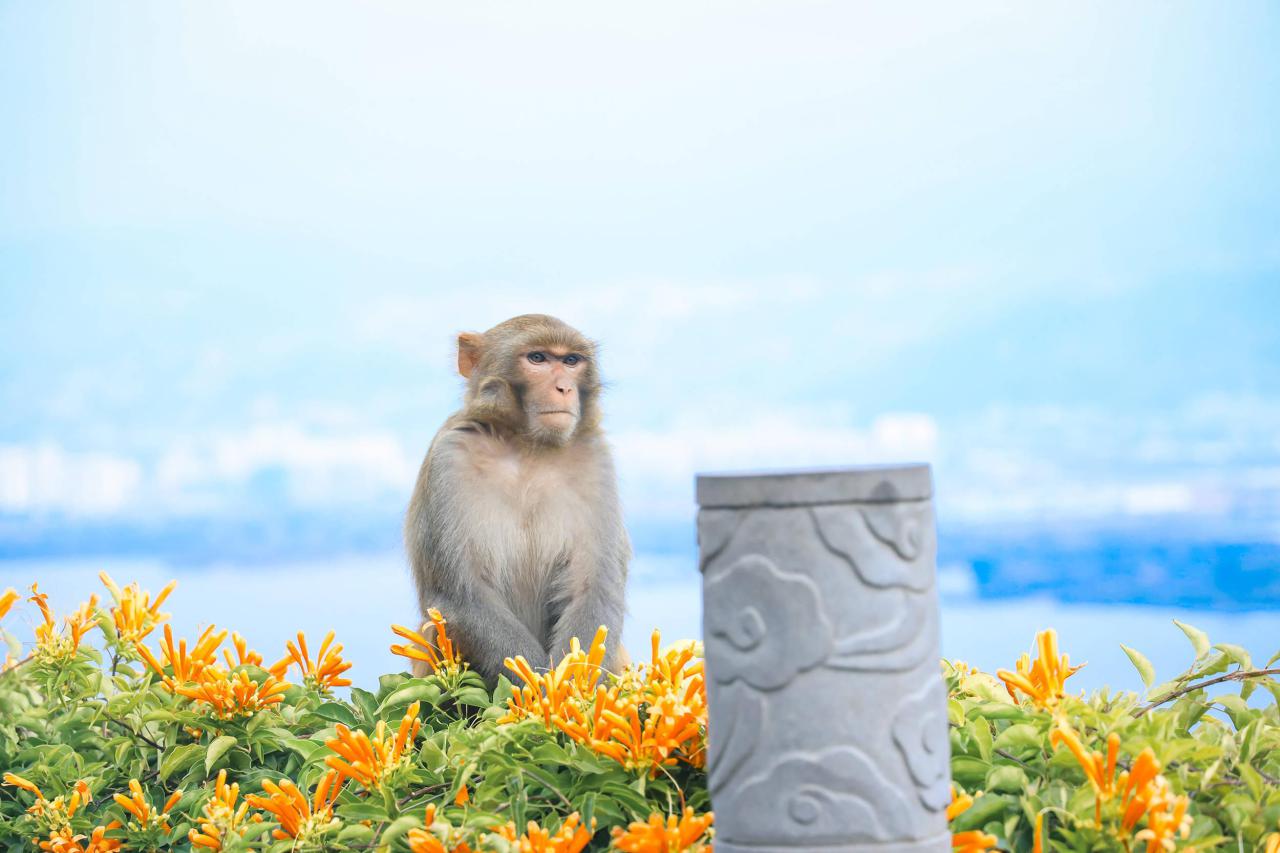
[458,314,600,446]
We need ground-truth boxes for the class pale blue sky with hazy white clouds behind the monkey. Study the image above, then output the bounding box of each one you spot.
[0,3,1280,553]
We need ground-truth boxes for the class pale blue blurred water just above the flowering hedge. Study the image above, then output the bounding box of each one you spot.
[0,555,1280,689]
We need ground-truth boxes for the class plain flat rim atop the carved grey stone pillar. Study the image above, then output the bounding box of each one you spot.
[695,462,933,510]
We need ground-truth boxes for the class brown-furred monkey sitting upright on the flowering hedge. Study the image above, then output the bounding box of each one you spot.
[404,314,631,686]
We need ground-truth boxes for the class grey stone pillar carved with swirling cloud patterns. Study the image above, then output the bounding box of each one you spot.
[698,465,951,853]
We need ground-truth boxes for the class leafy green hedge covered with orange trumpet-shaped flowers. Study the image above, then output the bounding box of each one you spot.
[0,574,1280,853]
